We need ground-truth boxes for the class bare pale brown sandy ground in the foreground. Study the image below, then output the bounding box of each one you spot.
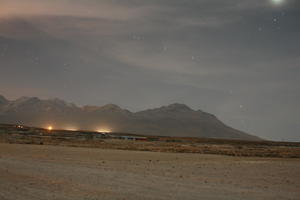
[0,144,300,200]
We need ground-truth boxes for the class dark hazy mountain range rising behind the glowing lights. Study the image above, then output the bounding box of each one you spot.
[0,96,260,140]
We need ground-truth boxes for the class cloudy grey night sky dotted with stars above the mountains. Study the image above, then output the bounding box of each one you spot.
[0,0,300,141]
